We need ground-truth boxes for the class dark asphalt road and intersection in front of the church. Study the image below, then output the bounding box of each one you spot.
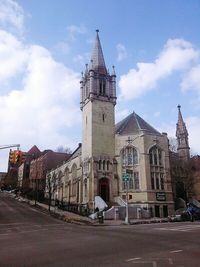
[0,193,200,267]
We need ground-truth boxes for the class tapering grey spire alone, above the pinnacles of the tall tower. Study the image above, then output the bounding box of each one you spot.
[91,30,107,74]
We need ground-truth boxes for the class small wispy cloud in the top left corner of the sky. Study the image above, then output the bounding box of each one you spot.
[0,0,24,33]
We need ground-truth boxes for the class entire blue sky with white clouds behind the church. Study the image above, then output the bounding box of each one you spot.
[0,0,200,171]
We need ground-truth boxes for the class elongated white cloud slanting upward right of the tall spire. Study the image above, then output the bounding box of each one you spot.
[119,39,199,99]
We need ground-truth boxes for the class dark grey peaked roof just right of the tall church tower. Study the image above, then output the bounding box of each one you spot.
[115,112,161,135]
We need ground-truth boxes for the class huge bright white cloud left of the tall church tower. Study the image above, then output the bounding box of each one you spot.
[0,34,81,171]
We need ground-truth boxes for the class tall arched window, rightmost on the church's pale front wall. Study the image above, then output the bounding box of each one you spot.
[149,146,164,190]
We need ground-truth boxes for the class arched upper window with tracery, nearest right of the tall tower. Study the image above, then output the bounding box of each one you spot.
[122,146,138,166]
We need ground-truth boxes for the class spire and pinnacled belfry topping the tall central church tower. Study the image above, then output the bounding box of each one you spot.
[80,30,116,110]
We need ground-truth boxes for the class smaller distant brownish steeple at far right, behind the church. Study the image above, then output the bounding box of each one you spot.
[176,105,190,160]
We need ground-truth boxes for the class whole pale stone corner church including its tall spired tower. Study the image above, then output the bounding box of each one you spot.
[46,31,174,217]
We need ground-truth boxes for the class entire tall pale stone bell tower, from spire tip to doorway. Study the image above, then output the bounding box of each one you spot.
[80,30,116,205]
